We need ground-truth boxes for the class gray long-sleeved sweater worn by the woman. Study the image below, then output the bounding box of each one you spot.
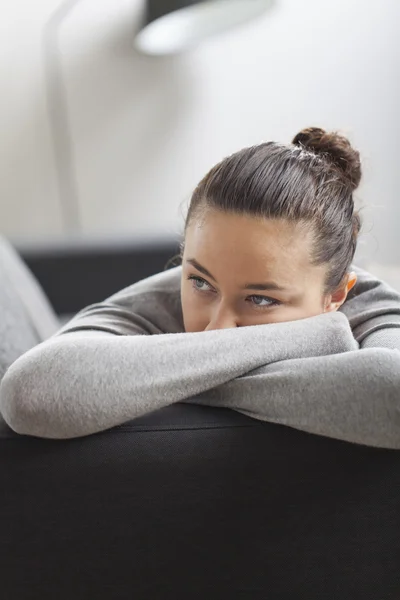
[0,265,400,449]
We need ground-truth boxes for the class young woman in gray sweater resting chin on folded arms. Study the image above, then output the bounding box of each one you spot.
[0,128,400,448]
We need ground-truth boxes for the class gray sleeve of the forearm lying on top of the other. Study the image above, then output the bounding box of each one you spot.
[0,312,358,438]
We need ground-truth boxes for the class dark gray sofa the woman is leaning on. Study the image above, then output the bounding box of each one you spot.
[0,241,400,600]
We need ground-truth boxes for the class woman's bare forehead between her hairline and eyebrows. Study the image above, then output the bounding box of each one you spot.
[184,211,324,287]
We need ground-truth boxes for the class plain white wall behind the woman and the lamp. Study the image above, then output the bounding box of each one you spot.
[0,0,400,278]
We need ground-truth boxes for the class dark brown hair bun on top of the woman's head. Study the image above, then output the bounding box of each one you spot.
[292,127,362,191]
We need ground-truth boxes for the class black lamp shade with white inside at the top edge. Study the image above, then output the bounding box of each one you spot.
[134,0,273,55]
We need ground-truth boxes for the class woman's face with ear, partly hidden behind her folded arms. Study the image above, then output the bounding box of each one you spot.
[181,209,356,332]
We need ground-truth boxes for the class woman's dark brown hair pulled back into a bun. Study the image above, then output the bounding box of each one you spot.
[185,127,361,294]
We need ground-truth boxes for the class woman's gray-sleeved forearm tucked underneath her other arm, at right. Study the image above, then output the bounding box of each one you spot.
[189,348,400,449]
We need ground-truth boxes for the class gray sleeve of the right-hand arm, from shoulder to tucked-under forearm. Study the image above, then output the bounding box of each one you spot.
[188,265,400,449]
